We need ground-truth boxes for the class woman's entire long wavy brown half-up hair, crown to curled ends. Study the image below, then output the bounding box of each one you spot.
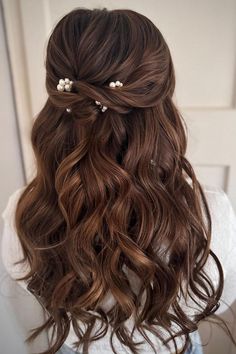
[15,8,227,354]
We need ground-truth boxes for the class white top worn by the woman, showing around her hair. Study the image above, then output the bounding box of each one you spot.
[1,186,236,354]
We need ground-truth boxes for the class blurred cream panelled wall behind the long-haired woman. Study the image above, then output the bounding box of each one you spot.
[0,0,236,354]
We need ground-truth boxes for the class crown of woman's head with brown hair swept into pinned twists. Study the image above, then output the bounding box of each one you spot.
[46,9,175,119]
